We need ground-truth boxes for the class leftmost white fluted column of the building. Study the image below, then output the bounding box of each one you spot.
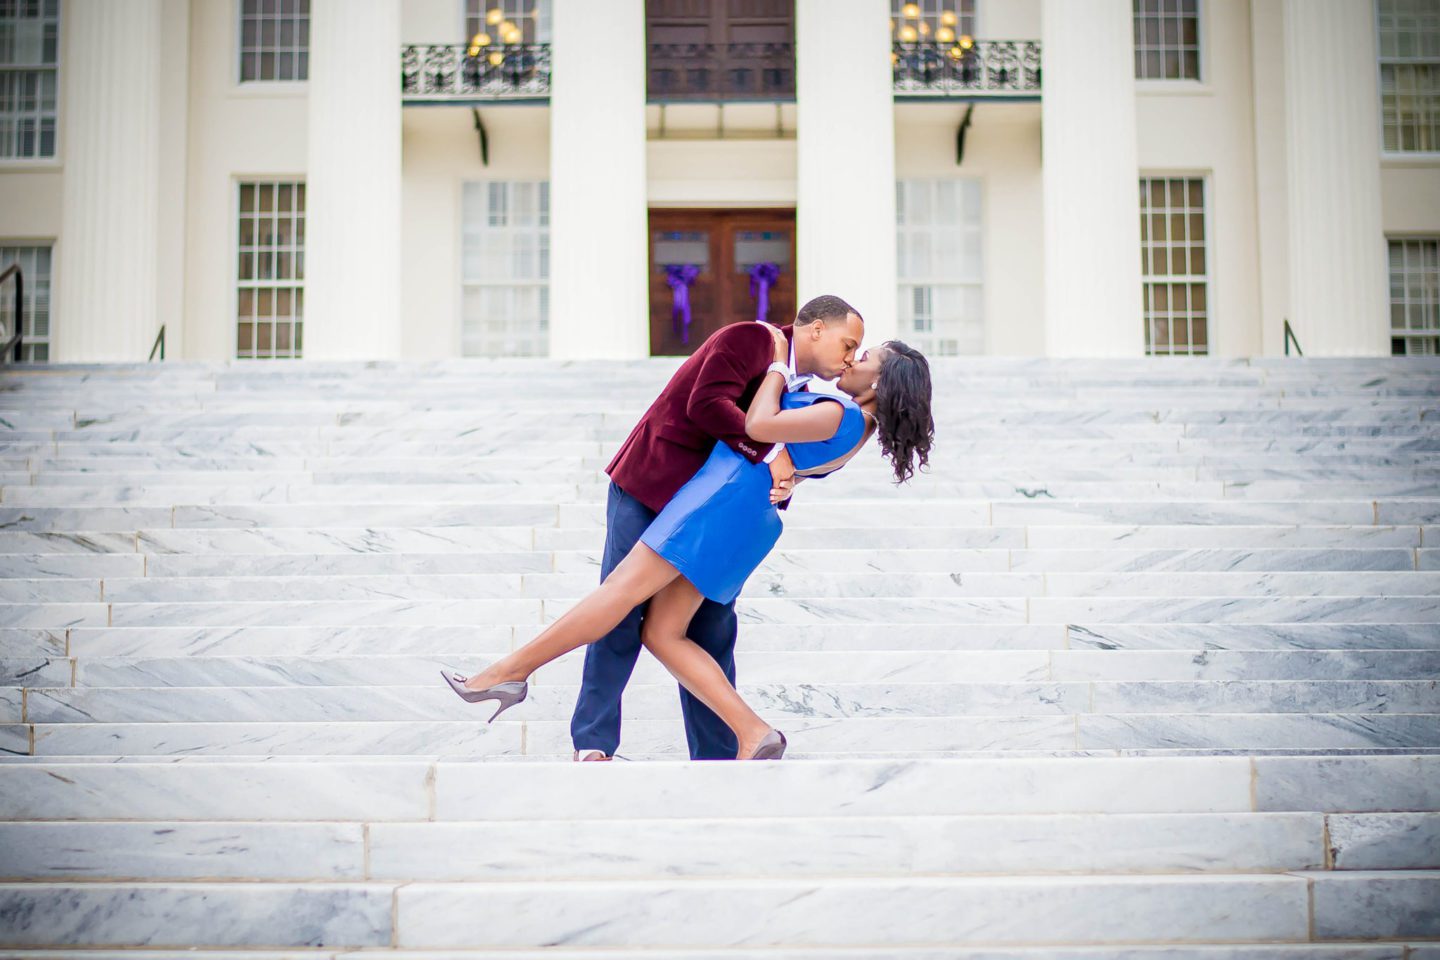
[50,0,163,363]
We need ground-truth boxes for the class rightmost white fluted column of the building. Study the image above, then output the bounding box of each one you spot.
[1284,0,1390,357]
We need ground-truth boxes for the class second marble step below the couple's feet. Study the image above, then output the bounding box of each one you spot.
[0,813,1393,882]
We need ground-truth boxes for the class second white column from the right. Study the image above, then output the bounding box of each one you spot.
[1041,0,1145,357]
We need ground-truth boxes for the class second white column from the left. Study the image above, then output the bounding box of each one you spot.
[304,0,400,360]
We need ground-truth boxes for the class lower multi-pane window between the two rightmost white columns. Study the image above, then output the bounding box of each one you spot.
[1140,177,1210,356]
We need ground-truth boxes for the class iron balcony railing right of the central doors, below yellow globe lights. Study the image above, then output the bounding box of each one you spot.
[890,40,1040,99]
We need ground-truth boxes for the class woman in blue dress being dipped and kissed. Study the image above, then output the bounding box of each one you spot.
[442,328,935,760]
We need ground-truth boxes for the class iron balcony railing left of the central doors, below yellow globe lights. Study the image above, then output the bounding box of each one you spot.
[400,43,550,104]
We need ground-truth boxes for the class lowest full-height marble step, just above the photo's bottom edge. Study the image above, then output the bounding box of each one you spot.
[0,871,1440,948]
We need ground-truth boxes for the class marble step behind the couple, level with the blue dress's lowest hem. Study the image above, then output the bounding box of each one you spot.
[84,569,1440,604]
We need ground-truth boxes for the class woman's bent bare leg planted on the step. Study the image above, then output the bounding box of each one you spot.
[636,575,770,757]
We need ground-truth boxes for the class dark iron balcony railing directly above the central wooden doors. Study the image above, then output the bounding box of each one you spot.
[647,43,795,104]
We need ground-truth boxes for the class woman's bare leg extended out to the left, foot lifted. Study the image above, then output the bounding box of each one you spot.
[465,544,681,689]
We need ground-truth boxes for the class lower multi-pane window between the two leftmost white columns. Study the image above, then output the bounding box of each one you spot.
[235,183,305,360]
